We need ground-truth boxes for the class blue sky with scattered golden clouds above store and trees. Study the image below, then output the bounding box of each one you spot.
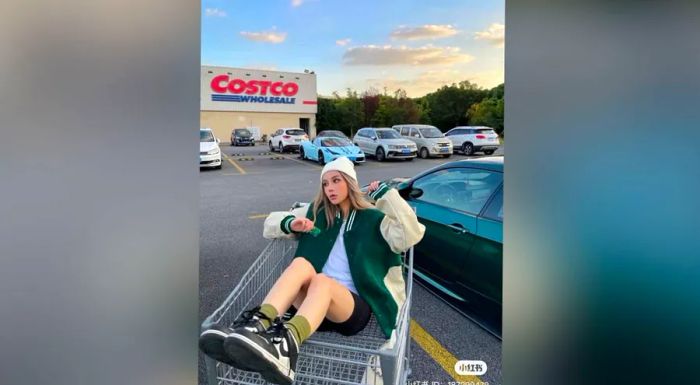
[201,0,505,97]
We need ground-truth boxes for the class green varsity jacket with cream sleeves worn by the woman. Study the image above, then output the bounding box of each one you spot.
[263,184,425,338]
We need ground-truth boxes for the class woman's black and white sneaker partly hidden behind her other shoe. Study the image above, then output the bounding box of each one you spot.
[199,306,272,370]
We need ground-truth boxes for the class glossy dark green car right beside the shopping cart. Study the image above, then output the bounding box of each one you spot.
[380,157,503,338]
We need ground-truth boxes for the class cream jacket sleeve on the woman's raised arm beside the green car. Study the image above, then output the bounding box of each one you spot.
[369,183,425,253]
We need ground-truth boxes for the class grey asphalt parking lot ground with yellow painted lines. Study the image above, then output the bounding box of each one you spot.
[199,143,503,385]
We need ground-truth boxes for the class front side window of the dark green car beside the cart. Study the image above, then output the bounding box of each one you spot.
[413,168,503,214]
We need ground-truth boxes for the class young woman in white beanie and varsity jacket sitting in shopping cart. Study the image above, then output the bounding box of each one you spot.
[200,157,425,385]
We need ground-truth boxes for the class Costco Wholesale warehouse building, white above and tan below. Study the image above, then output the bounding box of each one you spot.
[199,66,317,142]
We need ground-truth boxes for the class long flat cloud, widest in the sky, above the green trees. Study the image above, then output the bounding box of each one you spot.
[343,45,474,66]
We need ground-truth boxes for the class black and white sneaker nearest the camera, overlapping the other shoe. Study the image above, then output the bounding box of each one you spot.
[224,322,299,385]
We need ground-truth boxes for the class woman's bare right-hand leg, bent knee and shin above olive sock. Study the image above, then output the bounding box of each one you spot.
[295,274,355,333]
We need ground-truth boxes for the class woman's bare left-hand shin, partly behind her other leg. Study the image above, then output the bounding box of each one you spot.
[262,258,316,314]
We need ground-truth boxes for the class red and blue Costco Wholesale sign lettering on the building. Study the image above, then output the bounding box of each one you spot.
[210,75,306,104]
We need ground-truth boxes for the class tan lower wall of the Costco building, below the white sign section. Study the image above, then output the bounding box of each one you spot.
[199,111,316,142]
